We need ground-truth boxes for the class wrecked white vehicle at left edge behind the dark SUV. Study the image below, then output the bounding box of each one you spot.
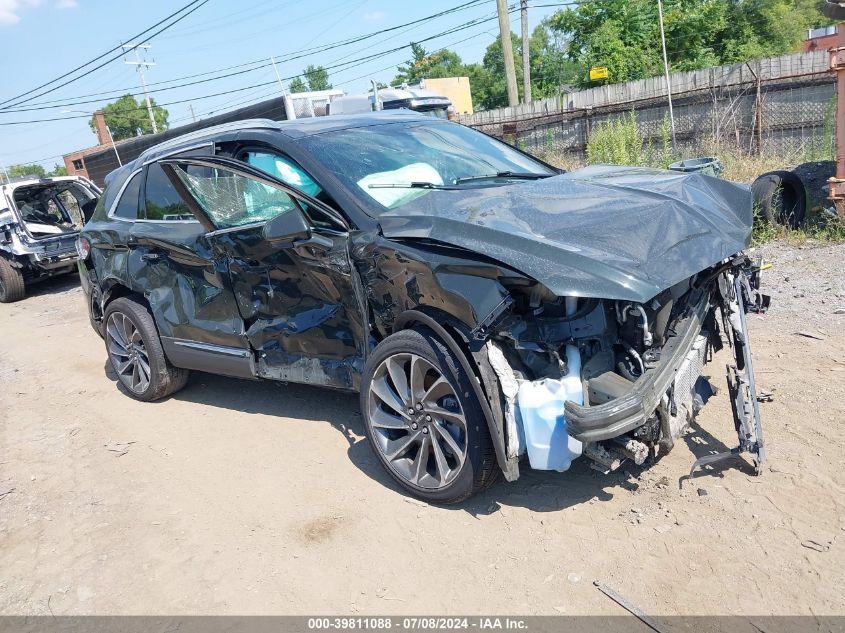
[0,176,100,303]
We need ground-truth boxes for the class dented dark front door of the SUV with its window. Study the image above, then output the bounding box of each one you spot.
[163,157,364,389]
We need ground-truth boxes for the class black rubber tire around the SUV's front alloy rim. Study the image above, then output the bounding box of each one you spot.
[361,328,500,504]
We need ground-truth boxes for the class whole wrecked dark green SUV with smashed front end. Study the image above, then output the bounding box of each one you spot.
[78,113,764,503]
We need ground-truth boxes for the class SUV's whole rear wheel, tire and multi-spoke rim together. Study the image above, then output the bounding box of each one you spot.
[103,297,190,402]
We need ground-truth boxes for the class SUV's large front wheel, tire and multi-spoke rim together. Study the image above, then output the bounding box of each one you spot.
[361,330,499,503]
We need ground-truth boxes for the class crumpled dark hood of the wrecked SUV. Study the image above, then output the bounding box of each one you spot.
[379,166,752,302]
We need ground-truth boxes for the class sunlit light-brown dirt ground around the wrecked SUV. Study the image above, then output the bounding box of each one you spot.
[0,239,845,615]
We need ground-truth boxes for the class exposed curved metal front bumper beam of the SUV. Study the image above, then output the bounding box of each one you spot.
[565,291,713,444]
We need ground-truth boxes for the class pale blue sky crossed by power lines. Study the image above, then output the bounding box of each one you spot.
[0,0,554,169]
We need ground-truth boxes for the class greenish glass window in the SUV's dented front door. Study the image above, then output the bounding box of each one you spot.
[171,167,297,229]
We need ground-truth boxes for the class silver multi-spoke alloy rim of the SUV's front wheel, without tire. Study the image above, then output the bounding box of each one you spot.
[368,354,467,490]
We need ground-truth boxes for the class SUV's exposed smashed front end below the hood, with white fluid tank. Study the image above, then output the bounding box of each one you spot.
[478,254,768,474]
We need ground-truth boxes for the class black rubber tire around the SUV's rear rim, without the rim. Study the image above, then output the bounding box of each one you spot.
[103,297,190,402]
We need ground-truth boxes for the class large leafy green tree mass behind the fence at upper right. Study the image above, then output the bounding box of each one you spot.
[546,0,829,86]
